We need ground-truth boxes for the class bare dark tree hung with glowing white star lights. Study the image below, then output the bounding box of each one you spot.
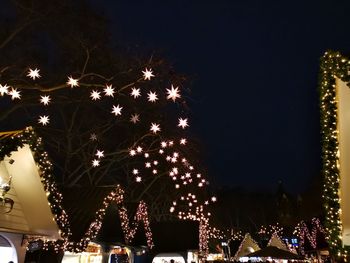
[0,1,210,228]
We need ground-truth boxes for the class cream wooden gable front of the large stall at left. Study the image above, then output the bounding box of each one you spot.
[0,145,60,239]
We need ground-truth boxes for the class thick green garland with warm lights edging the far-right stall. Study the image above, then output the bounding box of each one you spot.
[319,51,350,257]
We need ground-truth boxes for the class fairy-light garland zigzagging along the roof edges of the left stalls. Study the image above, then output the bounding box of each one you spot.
[0,127,153,252]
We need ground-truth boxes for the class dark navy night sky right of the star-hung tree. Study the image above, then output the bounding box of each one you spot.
[91,0,350,192]
